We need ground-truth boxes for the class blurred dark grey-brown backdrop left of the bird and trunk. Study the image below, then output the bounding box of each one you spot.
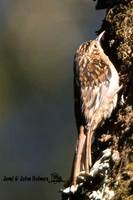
[0,0,104,200]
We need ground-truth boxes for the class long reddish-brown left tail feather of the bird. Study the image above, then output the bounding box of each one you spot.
[72,126,86,185]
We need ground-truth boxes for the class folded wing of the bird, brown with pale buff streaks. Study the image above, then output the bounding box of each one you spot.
[74,54,111,127]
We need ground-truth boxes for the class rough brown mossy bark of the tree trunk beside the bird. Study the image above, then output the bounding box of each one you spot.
[63,0,133,200]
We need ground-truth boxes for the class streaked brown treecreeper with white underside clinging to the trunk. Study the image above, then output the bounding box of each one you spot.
[71,32,121,185]
